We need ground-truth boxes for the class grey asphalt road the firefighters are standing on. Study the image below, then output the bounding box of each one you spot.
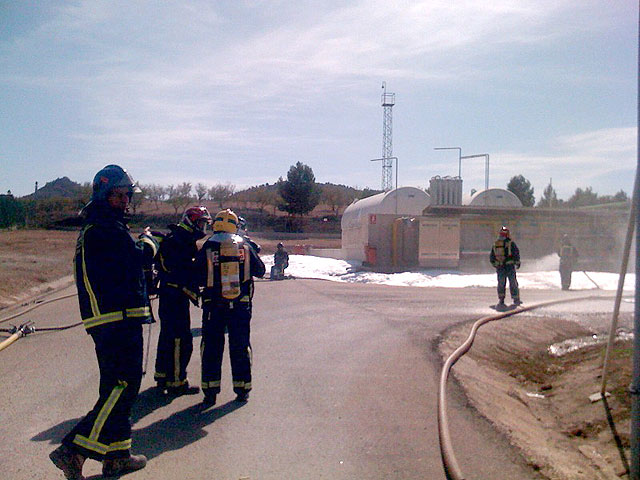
[0,279,620,480]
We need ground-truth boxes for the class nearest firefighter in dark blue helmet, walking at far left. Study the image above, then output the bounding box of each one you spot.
[49,165,151,479]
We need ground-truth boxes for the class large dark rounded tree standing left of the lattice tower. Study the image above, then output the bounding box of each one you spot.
[278,162,320,216]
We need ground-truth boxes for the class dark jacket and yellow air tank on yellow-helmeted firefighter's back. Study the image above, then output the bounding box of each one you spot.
[196,232,265,308]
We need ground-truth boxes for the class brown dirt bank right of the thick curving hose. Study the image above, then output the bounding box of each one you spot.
[440,314,631,480]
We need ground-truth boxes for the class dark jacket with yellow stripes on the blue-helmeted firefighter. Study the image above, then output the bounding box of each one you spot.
[74,204,151,333]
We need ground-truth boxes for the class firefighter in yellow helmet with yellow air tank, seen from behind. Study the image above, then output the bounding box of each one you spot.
[196,209,265,405]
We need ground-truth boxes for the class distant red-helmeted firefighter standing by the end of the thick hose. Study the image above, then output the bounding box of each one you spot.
[489,226,522,308]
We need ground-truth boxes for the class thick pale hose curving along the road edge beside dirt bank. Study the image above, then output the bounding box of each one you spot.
[438,295,611,480]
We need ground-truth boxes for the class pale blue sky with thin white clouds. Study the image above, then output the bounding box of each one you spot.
[0,0,638,200]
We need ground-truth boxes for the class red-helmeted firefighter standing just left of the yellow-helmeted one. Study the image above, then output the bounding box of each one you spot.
[154,206,211,395]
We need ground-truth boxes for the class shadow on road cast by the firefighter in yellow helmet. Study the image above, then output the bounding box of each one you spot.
[132,401,246,459]
